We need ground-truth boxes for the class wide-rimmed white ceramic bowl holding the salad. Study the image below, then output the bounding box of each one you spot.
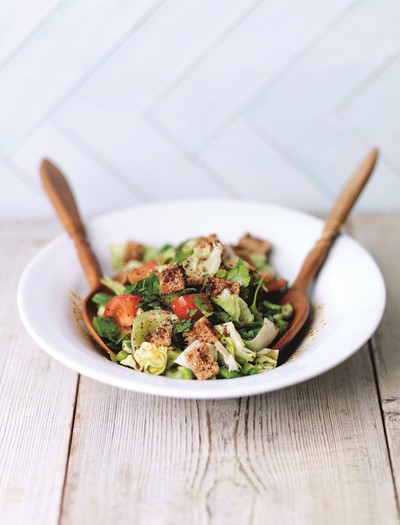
[18,200,385,399]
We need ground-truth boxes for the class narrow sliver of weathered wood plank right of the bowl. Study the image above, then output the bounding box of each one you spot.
[352,215,400,506]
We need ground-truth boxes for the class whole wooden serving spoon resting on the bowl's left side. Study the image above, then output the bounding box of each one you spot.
[40,159,115,355]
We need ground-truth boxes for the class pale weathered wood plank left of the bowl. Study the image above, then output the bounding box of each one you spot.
[0,221,77,525]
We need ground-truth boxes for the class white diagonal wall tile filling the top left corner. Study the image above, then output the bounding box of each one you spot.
[0,0,161,153]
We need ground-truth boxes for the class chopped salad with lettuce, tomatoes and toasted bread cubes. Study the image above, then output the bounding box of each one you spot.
[92,234,293,380]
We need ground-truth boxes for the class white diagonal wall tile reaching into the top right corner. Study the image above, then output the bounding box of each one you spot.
[250,0,400,146]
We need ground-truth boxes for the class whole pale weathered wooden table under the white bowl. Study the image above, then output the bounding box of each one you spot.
[0,216,400,525]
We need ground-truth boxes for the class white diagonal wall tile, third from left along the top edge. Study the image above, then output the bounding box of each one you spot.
[153,0,351,148]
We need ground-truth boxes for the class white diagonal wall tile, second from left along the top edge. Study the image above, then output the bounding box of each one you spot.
[58,0,259,126]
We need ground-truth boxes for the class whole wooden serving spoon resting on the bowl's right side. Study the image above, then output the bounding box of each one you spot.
[274,148,378,350]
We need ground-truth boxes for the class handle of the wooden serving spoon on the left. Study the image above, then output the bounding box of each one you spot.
[40,159,101,290]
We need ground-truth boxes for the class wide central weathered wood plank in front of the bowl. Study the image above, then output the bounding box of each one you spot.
[61,347,398,525]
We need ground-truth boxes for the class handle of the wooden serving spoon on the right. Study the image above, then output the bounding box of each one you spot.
[293,148,378,290]
